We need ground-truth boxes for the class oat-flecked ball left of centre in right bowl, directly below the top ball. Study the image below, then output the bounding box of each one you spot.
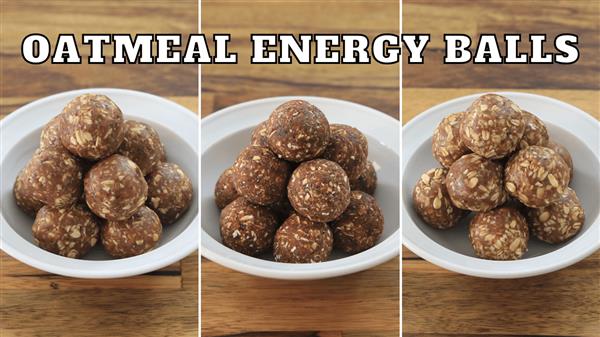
[446,153,506,212]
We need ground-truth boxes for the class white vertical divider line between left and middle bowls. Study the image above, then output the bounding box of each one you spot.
[196,0,202,337]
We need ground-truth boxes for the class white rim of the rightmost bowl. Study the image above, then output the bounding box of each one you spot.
[401,91,600,278]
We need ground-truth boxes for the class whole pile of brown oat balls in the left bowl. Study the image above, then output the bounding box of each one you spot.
[13,94,192,258]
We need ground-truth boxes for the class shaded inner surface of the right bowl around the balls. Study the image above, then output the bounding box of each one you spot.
[402,122,600,259]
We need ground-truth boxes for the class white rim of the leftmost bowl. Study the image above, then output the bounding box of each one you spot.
[0,87,200,279]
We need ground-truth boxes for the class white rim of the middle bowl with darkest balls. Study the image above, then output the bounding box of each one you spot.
[200,95,401,280]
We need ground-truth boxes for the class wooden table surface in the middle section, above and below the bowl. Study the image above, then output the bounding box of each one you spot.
[201,0,399,337]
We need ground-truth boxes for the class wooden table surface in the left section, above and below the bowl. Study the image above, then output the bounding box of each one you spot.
[0,0,198,337]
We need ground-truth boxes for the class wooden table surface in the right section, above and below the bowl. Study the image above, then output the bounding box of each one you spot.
[402,1,600,337]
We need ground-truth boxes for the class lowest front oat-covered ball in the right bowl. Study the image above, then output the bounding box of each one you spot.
[469,207,529,260]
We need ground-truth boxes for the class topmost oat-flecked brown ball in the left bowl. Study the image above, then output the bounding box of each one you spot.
[60,94,123,160]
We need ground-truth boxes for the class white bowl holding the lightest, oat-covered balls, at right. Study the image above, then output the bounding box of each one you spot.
[402,92,600,278]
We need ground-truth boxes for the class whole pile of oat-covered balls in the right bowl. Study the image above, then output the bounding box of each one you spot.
[413,94,585,260]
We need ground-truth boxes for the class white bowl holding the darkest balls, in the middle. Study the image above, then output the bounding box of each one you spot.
[200,97,400,280]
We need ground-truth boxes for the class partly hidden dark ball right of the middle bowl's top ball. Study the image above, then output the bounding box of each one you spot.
[323,124,368,180]
